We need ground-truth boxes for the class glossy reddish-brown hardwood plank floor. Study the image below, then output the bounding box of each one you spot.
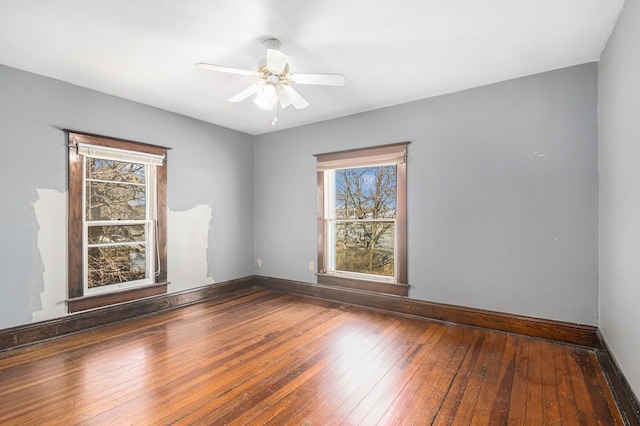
[0,288,622,425]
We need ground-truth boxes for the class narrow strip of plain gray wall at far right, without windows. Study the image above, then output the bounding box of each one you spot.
[598,0,640,395]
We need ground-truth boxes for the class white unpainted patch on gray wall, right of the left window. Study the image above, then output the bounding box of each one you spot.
[167,205,214,293]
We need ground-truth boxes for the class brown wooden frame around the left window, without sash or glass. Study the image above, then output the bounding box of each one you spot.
[66,130,169,312]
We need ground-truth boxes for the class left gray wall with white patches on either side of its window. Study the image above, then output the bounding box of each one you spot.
[0,66,253,328]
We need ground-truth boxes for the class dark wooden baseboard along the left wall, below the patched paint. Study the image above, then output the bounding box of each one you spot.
[0,276,254,351]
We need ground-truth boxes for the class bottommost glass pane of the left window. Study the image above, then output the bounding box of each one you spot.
[88,244,147,288]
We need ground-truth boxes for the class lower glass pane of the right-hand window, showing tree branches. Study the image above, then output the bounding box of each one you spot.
[334,222,395,277]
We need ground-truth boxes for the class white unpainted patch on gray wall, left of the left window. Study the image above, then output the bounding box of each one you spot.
[31,189,67,322]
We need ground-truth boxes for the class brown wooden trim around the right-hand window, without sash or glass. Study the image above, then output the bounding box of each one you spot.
[315,142,410,296]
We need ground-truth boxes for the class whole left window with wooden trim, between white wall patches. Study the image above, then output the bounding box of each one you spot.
[68,132,167,312]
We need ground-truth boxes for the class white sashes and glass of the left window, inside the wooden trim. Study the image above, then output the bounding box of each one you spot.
[83,158,156,295]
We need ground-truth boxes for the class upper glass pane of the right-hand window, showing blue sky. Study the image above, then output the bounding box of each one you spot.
[335,165,396,219]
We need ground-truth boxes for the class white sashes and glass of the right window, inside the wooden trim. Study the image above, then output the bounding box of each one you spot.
[325,164,397,280]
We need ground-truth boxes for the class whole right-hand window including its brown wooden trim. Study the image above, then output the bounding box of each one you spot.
[316,143,408,296]
